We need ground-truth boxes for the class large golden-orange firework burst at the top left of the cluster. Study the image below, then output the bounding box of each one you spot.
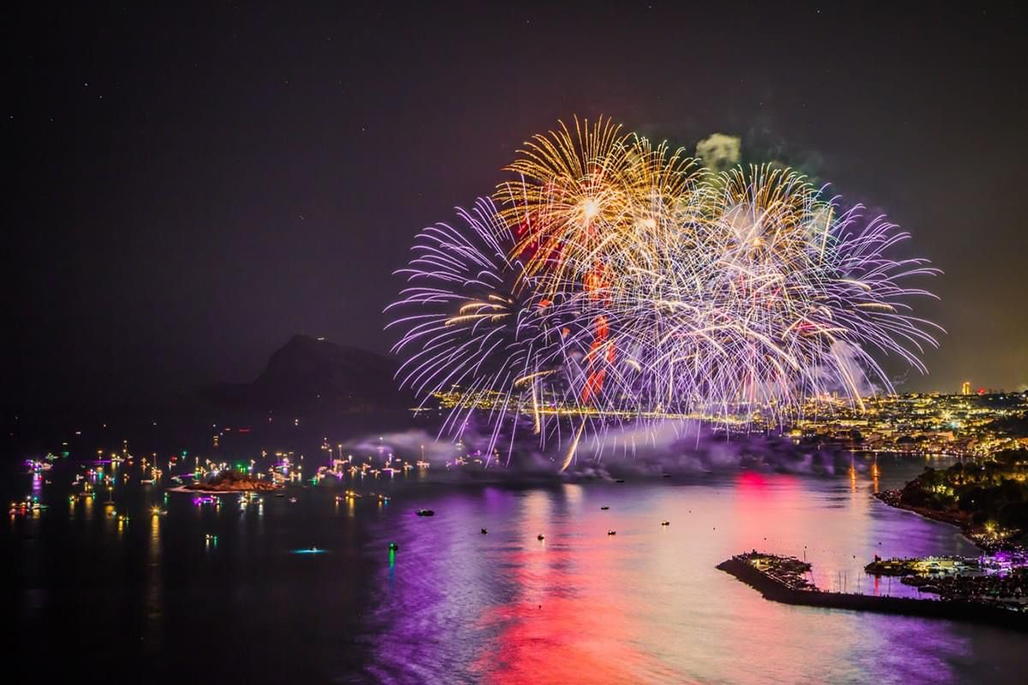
[494,119,699,294]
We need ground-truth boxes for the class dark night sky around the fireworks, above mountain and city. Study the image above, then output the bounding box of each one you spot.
[0,2,1028,402]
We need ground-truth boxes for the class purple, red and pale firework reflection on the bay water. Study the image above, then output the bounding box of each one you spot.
[361,468,1003,683]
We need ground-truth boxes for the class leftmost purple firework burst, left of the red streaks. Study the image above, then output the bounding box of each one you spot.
[387,199,600,455]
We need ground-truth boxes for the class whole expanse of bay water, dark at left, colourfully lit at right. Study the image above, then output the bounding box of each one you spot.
[0,452,1028,683]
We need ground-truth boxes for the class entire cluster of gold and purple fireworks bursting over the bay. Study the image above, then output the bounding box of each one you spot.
[390,119,937,467]
